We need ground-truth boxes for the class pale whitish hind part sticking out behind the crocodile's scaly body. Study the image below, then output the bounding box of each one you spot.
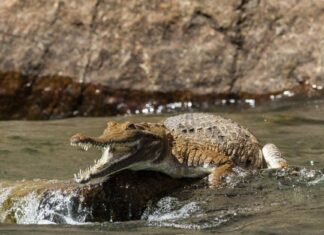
[262,144,288,168]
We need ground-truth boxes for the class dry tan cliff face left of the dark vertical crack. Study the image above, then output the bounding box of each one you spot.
[0,0,239,93]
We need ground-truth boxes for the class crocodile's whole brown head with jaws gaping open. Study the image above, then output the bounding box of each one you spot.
[70,122,165,183]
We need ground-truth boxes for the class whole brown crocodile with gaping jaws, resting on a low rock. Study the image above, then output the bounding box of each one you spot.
[70,113,287,187]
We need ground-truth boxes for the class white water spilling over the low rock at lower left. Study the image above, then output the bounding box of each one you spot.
[0,183,91,224]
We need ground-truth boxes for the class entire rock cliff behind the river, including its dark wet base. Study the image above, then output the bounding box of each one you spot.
[0,0,324,119]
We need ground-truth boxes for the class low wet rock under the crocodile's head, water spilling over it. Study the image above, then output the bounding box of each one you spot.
[0,171,193,223]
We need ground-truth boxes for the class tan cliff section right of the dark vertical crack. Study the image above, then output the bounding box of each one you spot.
[233,0,324,95]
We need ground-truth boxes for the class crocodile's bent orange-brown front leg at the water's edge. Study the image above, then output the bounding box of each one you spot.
[208,162,234,188]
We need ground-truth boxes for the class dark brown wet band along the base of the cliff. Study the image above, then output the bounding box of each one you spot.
[0,73,233,120]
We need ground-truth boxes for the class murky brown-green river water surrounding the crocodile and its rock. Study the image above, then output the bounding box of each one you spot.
[0,100,324,234]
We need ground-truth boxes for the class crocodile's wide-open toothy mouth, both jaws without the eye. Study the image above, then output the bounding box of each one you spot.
[70,134,140,183]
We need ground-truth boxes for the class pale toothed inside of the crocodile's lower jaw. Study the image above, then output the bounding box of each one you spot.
[74,145,113,183]
